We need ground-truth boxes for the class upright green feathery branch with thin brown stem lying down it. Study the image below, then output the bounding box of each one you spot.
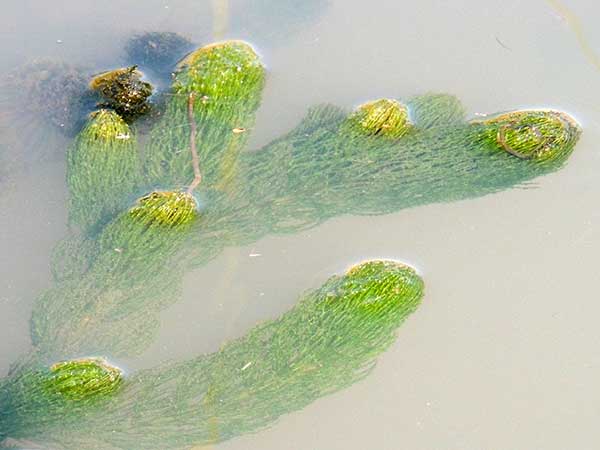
[145,41,265,189]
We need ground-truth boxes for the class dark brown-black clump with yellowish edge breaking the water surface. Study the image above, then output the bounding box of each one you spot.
[90,66,153,122]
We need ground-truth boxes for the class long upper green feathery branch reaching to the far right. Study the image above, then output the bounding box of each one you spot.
[236,99,580,221]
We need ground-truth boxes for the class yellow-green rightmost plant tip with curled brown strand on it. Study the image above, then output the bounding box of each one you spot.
[482,110,581,163]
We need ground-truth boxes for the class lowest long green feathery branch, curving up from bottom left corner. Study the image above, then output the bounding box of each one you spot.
[0,261,423,449]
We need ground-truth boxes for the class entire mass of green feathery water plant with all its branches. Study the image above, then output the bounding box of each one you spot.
[0,37,580,449]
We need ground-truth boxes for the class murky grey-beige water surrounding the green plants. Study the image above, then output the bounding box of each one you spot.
[0,0,600,450]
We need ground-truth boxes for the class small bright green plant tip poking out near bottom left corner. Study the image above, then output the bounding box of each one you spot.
[44,358,123,401]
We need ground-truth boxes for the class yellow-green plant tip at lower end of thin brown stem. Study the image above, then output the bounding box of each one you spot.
[130,191,197,226]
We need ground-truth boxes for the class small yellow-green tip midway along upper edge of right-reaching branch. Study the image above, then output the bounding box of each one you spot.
[348,99,412,138]
